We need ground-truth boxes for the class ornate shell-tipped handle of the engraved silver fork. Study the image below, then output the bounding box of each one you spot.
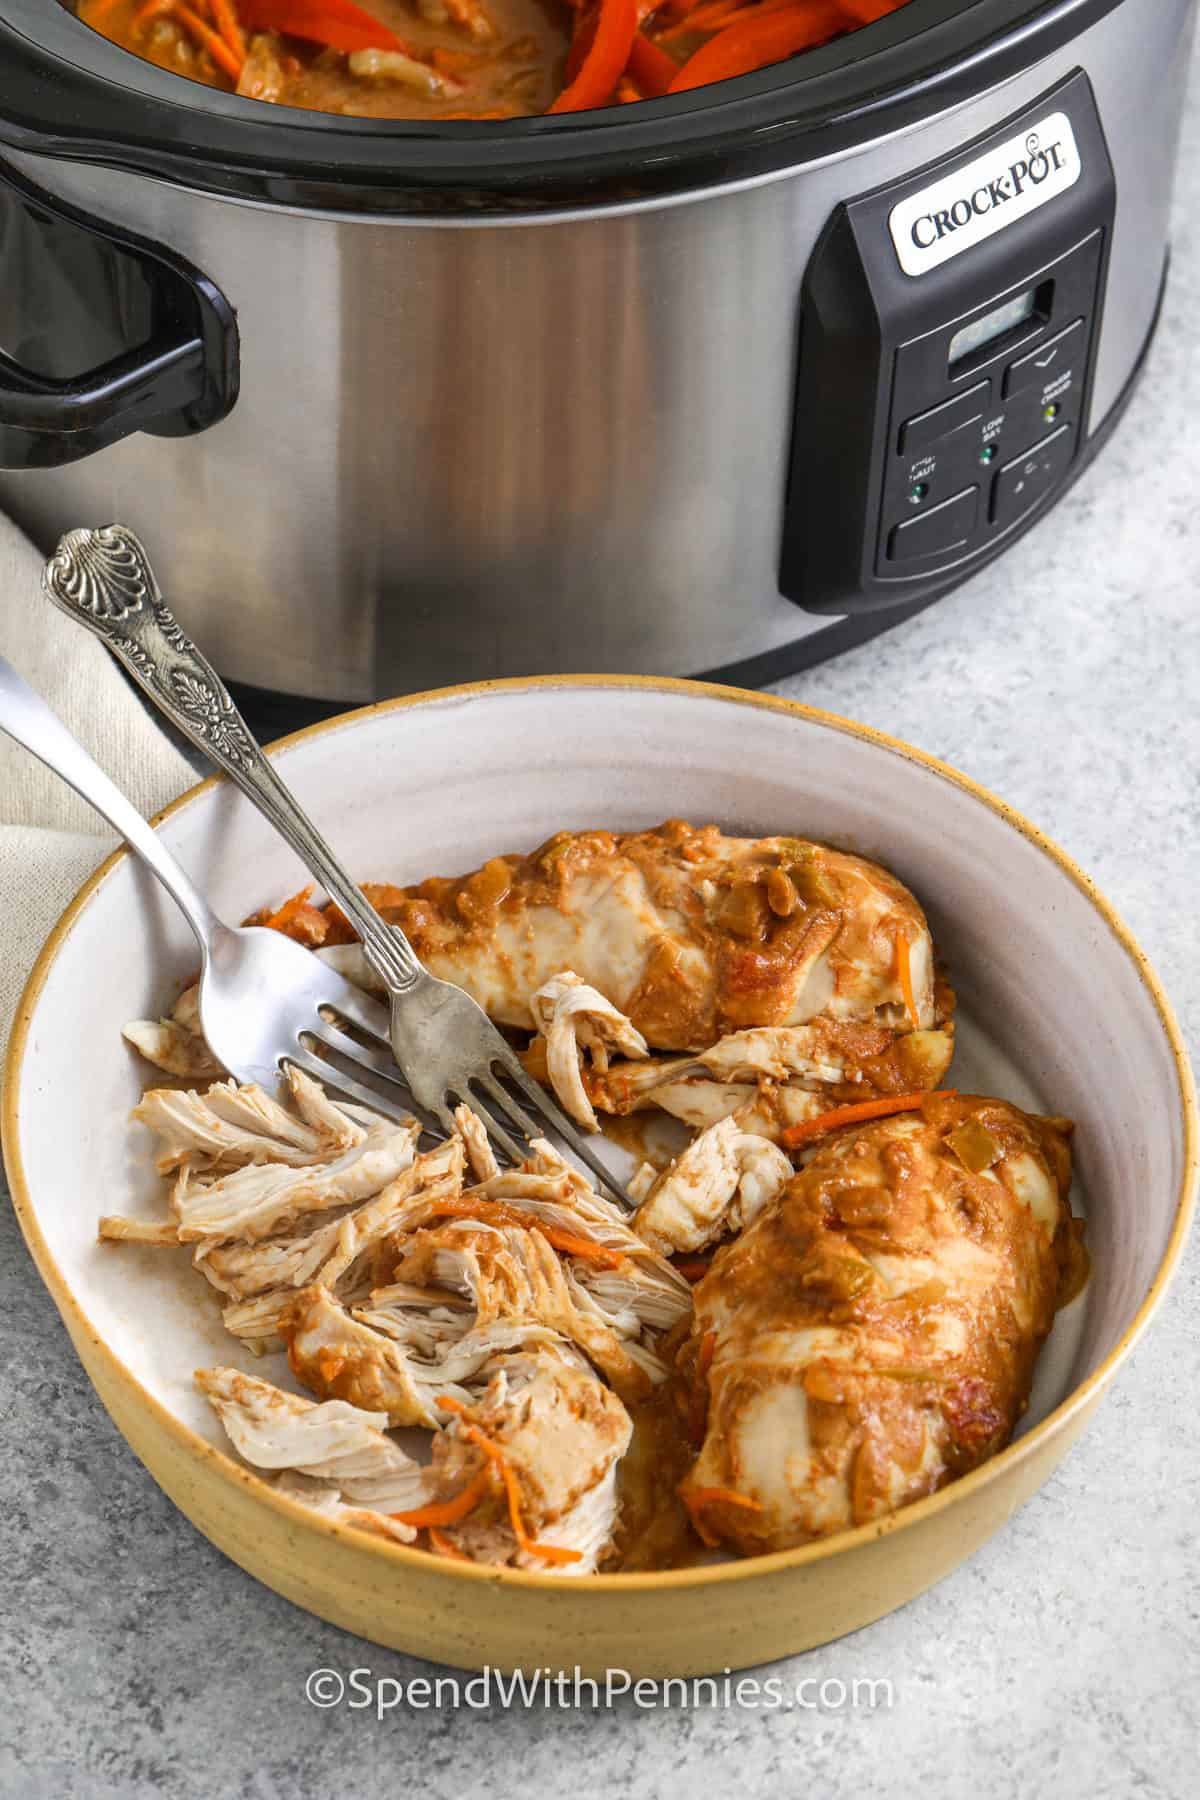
[43,526,423,994]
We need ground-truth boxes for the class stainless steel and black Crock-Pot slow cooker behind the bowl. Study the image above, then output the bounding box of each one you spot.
[0,0,1195,700]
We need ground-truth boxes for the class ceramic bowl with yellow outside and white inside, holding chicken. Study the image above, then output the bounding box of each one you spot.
[4,677,1196,1676]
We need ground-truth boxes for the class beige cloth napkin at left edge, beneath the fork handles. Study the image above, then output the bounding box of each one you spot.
[0,518,198,1071]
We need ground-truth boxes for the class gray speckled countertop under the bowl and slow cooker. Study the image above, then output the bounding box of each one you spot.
[0,63,1200,1800]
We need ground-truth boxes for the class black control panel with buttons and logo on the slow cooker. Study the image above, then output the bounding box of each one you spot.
[781,74,1115,614]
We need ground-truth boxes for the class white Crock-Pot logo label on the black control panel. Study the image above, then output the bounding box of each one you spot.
[889,113,1081,275]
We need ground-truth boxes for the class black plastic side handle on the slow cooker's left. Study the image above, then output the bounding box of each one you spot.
[0,162,237,470]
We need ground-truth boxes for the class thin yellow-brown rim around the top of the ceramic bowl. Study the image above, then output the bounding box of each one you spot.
[0,675,1200,1593]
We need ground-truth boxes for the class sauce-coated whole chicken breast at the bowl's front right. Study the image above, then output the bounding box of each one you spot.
[680,1096,1072,1553]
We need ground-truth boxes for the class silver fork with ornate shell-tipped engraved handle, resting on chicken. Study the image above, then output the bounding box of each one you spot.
[45,526,631,1208]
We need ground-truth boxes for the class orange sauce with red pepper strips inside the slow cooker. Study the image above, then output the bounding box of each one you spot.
[76,0,905,119]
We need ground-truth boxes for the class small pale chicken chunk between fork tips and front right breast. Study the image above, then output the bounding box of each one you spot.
[633,1118,793,1255]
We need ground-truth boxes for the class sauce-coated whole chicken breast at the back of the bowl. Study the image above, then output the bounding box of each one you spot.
[275,819,941,1055]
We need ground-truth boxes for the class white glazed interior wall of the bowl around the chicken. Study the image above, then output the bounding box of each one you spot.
[9,686,1186,1476]
